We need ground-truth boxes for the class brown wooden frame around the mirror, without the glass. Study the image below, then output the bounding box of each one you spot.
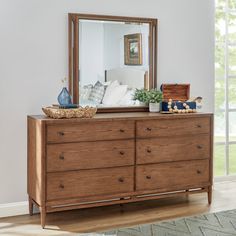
[68,13,158,113]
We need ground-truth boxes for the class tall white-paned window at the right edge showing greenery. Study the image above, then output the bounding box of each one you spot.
[214,0,236,176]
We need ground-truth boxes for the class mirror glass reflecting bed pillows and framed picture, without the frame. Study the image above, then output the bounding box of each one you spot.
[79,20,149,107]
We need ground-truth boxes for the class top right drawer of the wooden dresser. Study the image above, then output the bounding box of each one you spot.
[137,117,210,138]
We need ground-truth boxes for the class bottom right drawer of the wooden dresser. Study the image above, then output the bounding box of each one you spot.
[136,160,210,191]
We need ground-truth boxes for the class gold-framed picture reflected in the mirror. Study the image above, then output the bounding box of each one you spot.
[124,33,143,65]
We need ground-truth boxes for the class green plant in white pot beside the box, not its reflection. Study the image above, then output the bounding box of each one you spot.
[146,89,162,112]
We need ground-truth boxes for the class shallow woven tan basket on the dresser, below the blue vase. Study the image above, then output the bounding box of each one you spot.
[42,106,97,119]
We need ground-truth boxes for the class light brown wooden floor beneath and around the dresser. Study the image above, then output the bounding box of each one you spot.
[0,181,236,236]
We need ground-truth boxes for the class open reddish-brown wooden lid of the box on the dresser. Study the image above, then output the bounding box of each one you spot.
[161,84,190,102]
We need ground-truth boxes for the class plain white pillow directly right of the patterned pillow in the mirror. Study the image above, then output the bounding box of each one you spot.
[102,81,128,105]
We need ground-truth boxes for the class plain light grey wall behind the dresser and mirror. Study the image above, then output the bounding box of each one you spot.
[0,0,214,203]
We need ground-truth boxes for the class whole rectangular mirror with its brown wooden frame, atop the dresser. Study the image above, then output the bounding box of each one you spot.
[69,14,157,112]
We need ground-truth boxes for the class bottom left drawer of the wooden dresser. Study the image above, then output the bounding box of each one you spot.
[47,167,134,200]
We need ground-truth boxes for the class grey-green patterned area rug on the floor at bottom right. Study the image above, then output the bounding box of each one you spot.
[99,210,236,236]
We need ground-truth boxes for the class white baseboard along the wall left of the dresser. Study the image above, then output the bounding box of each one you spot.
[0,201,29,218]
